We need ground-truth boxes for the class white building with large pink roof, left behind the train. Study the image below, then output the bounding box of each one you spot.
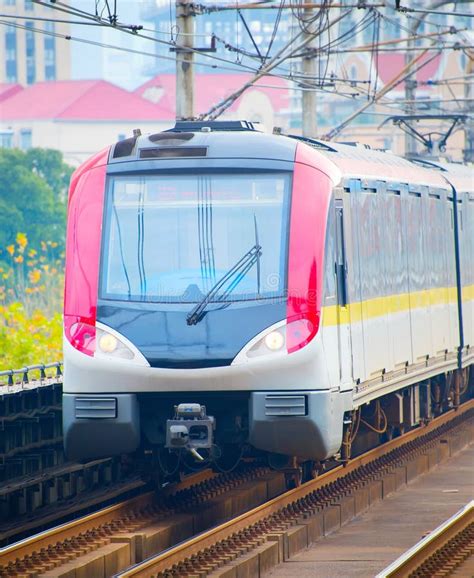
[0,80,174,166]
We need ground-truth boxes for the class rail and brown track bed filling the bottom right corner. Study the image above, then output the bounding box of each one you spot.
[376,500,474,578]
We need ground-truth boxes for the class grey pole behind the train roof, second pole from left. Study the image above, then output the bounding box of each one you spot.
[301,8,317,138]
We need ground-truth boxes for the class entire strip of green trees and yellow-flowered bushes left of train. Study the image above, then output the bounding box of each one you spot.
[0,148,73,369]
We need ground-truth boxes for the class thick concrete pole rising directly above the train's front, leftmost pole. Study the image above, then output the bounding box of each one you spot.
[176,0,194,120]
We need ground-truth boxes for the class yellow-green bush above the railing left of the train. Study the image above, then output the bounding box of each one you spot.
[0,303,62,369]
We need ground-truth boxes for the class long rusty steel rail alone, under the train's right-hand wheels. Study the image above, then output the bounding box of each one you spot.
[116,400,474,578]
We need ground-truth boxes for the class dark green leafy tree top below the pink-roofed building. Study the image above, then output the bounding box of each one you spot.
[0,149,73,250]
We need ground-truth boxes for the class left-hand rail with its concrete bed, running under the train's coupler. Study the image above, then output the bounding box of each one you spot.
[0,464,285,578]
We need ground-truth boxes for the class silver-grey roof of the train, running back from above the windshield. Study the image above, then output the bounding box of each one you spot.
[109,121,473,192]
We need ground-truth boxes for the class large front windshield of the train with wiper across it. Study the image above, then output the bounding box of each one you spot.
[101,172,291,303]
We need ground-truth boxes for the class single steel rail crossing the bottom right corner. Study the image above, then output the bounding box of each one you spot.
[375,500,474,578]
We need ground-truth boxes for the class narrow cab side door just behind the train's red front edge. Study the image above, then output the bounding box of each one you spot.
[335,199,352,389]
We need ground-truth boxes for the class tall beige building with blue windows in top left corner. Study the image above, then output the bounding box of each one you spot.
[0,0,70,86]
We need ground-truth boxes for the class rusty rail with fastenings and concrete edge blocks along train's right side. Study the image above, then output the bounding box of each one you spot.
[116,401,474,578]
